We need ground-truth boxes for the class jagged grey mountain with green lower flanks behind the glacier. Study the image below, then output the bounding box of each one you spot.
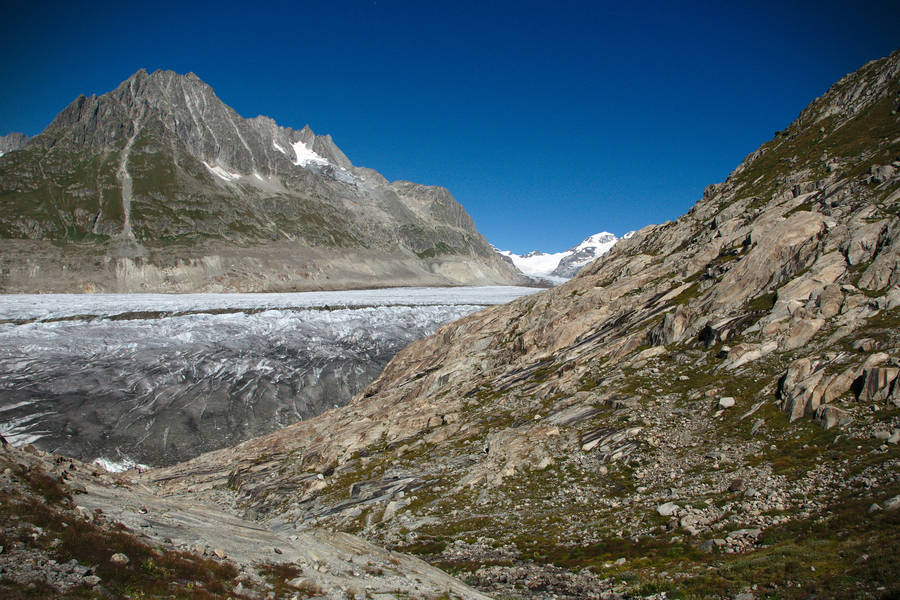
[0,70,522,292]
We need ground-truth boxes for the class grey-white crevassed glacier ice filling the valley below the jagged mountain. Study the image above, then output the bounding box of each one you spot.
[0,287,536,468]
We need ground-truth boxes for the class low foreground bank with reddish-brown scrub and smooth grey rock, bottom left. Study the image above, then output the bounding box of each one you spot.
[0,438,488,600]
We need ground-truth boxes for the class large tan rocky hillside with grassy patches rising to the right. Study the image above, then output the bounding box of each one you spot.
[134,52,900,598]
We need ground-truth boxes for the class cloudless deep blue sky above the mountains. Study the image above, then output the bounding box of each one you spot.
[0,0,900,252]
